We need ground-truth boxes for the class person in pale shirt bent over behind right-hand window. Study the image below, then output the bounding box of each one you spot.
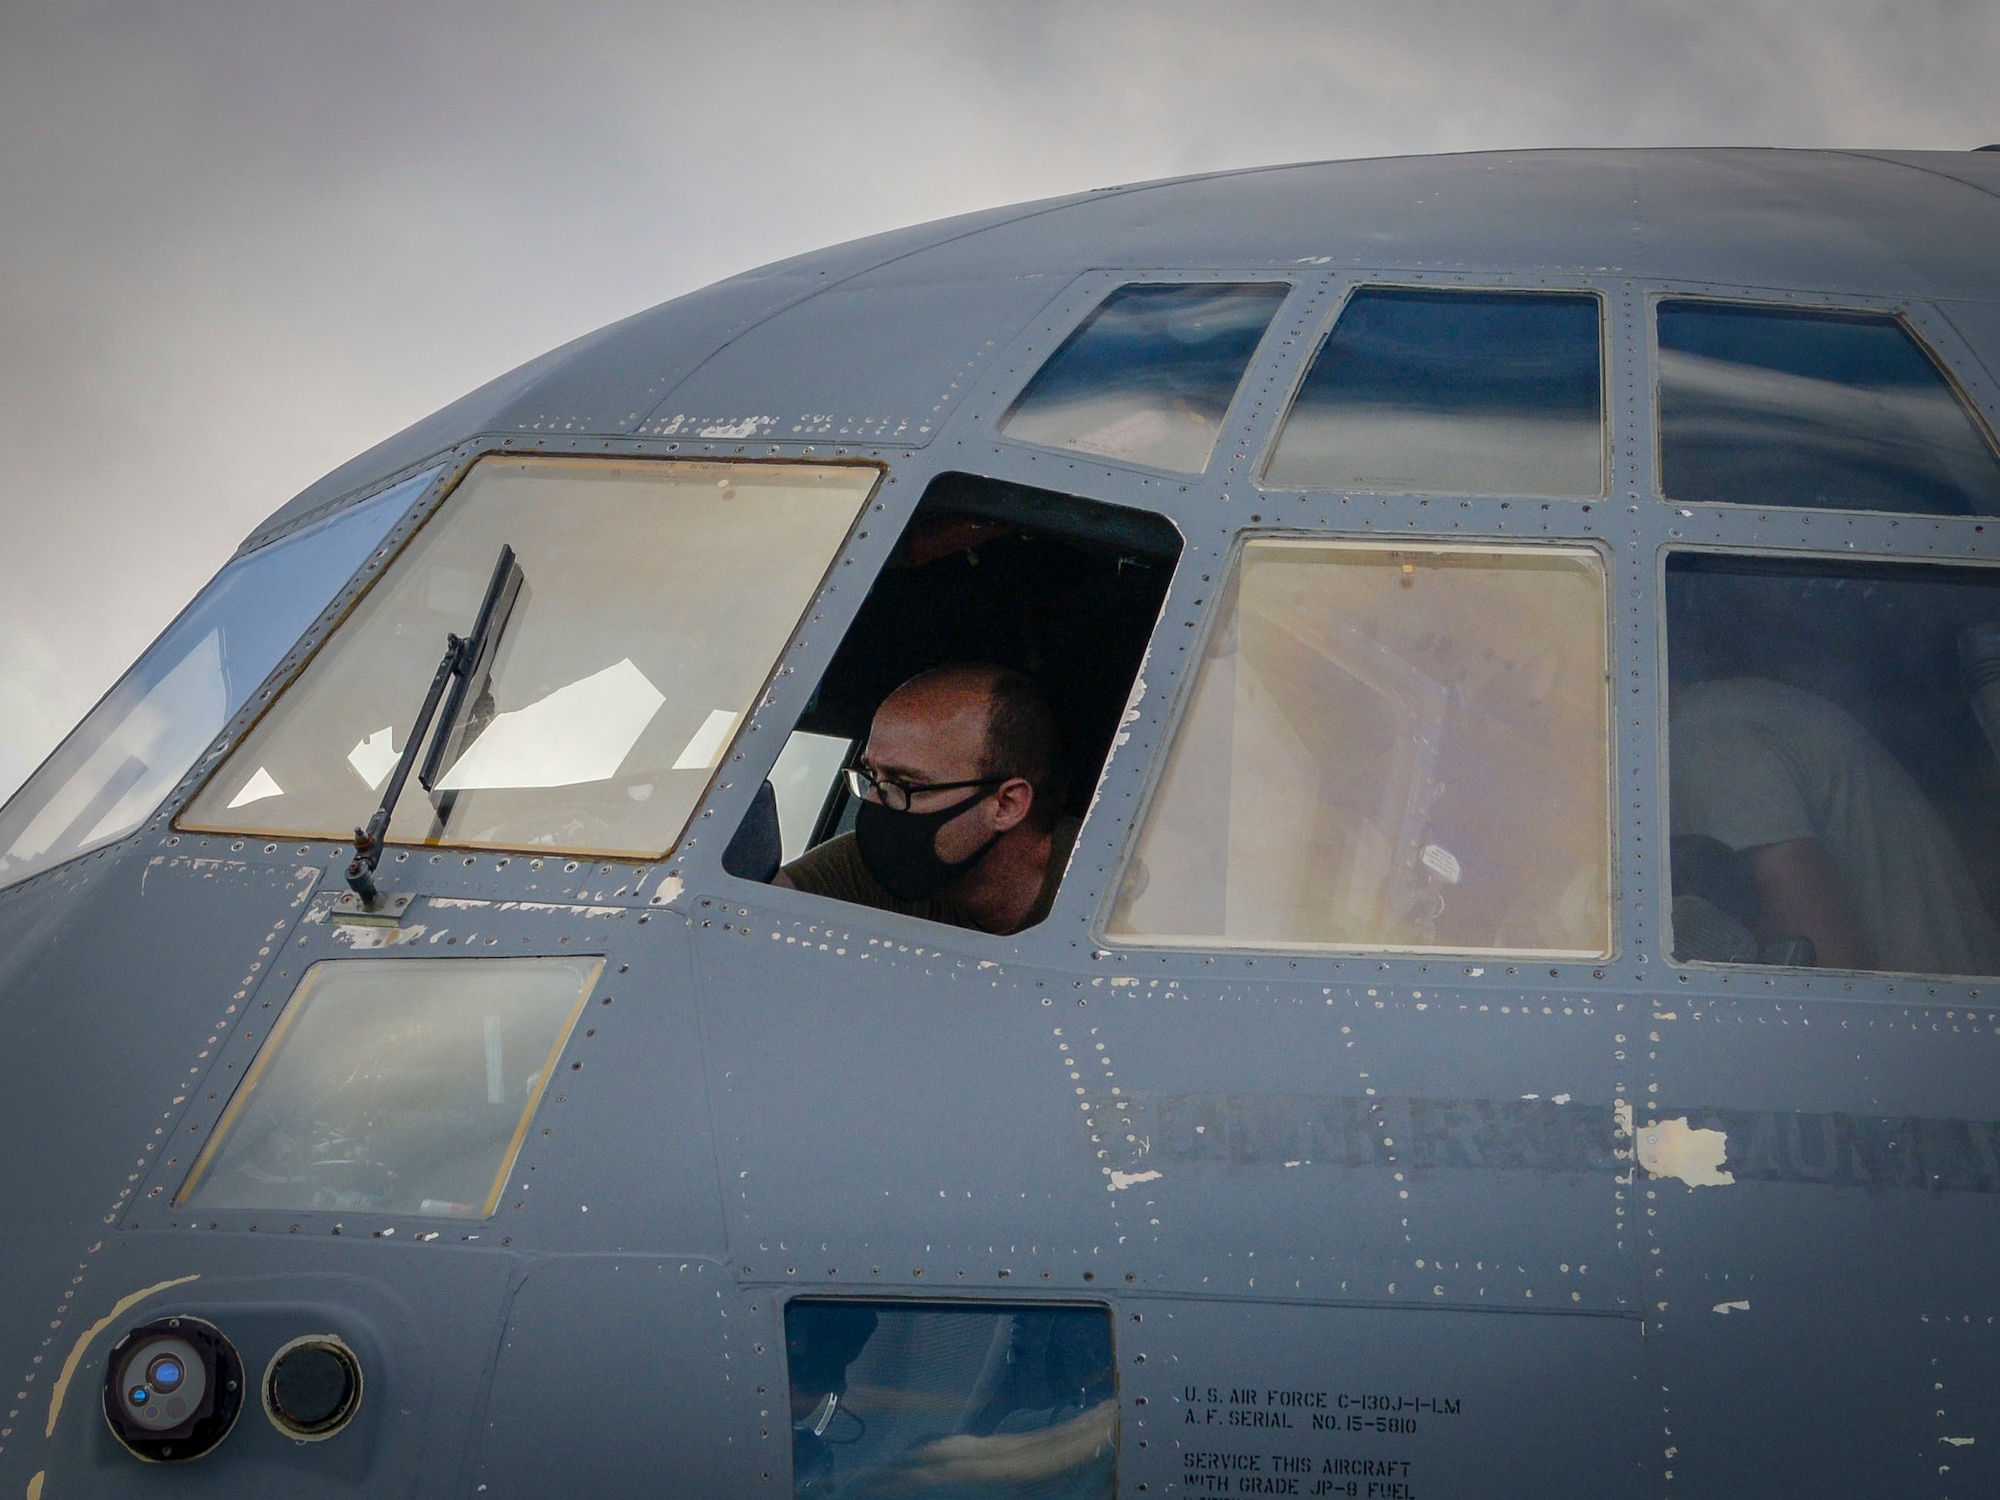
[1670,676,2000,974]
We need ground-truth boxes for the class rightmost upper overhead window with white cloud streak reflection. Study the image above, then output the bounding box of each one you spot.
[1660,300,2000,516]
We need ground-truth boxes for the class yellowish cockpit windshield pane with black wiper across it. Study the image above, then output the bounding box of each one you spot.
[182,458,876,858]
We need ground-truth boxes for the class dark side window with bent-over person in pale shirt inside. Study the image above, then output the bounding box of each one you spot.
[1666,554,2000,974]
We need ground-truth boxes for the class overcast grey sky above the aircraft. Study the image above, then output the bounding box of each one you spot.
[0,0,2000,794]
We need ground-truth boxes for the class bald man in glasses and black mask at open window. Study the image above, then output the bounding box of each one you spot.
[774,666,1078,934]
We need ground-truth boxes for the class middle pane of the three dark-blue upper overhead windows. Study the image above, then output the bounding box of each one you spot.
[1264,286,1604,496]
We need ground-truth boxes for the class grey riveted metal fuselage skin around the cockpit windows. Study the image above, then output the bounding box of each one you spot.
[0,150,2000,1500]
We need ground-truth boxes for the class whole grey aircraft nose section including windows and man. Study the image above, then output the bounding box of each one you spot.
[0,150,2000,1500]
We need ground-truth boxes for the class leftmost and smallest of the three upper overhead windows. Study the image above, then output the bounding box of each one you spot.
[1000,282,1290,474]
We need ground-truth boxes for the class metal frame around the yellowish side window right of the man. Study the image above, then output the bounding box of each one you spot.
[1078,526,1624,968]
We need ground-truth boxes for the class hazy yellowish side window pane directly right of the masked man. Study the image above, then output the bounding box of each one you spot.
[1108,538,1610,956]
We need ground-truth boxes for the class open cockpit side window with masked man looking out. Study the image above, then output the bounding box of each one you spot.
[744,474,1180,932]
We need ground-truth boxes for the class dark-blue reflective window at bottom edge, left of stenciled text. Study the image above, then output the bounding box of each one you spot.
[784,1300,1118,1500]
